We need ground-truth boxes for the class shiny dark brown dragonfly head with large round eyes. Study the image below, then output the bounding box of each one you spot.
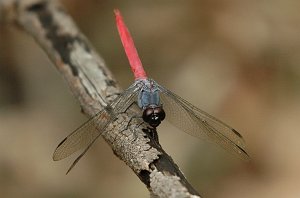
[143,106,166,128]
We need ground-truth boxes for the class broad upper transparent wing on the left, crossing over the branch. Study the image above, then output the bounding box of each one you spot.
[53,86,139,161]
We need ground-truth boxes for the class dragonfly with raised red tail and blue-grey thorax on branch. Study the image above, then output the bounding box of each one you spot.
[53,9,250,173]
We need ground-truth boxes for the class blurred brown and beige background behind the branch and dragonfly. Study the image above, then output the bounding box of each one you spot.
[0,0,300,198]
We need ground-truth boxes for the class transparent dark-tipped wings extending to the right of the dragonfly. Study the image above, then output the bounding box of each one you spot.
[158,85,250,160]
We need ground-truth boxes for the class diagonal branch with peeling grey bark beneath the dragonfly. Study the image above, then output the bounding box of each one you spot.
[0,0,199,197]
